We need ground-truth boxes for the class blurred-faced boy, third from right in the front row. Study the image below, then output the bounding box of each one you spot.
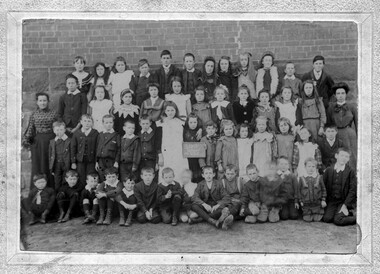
[277,156,298,220]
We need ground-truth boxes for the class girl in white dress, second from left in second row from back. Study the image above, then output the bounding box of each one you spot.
[89,86,112,132]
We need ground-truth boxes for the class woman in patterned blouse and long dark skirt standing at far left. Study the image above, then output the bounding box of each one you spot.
[23,92,58,187]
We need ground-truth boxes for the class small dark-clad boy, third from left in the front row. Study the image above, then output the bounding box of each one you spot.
[80,173,99,224]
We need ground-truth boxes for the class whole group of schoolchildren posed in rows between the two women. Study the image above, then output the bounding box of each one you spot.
[25,50,357,230]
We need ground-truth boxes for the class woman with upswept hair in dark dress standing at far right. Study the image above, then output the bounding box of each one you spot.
[327,82,358,169]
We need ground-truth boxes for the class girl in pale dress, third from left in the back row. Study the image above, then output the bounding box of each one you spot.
[108,56,133,109]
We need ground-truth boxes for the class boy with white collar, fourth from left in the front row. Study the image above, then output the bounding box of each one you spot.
[95,167,123,225]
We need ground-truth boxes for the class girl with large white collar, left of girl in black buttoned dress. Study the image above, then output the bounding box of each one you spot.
[211,85,236,130]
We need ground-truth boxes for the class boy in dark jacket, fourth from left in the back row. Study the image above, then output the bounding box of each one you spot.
[129,59,153,107]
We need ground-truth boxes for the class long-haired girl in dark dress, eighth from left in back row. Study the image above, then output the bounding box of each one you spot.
[218,56,237,102]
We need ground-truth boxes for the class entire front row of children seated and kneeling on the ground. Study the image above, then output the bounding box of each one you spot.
[28,148,357,230]
